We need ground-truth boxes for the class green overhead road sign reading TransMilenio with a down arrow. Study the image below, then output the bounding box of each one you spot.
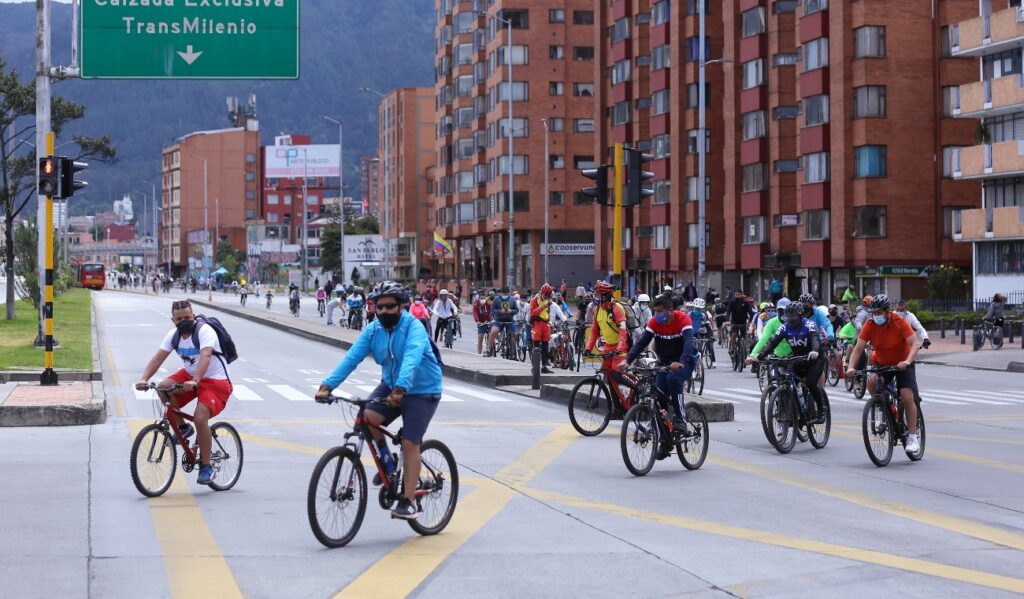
[79,0,300,79]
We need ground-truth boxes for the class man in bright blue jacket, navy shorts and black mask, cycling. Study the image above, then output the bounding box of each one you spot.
[315,281,441,520]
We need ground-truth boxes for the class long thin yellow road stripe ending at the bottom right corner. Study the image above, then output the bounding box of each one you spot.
[521,488,1024,593]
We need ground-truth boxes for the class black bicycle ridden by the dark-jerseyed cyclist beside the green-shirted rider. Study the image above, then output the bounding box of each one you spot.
[761,355,831,454]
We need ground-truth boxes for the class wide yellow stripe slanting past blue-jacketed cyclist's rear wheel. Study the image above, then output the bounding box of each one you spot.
[336,424,580,597]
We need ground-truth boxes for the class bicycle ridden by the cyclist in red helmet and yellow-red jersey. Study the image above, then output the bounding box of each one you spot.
[568,352,637,437]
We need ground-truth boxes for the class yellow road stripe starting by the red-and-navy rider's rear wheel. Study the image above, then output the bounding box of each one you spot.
[711,456,1024,551]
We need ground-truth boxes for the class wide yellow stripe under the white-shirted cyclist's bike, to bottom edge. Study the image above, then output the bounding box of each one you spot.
[128,420,242,598]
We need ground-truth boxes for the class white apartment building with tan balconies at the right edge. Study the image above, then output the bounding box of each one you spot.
[942,0,1024,302]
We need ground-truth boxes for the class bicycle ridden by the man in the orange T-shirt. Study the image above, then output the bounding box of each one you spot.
[861,367,925,468]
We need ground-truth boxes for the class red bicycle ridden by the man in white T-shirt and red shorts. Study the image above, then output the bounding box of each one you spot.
[129,383,245,497]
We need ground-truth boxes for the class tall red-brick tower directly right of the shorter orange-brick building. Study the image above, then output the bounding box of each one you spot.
[432,0,597,289]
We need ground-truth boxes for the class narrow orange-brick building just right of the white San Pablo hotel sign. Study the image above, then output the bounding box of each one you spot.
[373,87,435,280]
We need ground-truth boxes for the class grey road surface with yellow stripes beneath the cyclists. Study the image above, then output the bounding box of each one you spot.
[0,292,1024,597]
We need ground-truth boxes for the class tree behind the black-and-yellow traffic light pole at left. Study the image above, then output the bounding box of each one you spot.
[0,55,117,320]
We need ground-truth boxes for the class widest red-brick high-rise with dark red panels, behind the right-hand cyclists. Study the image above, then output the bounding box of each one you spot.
[597,0,977,300]
